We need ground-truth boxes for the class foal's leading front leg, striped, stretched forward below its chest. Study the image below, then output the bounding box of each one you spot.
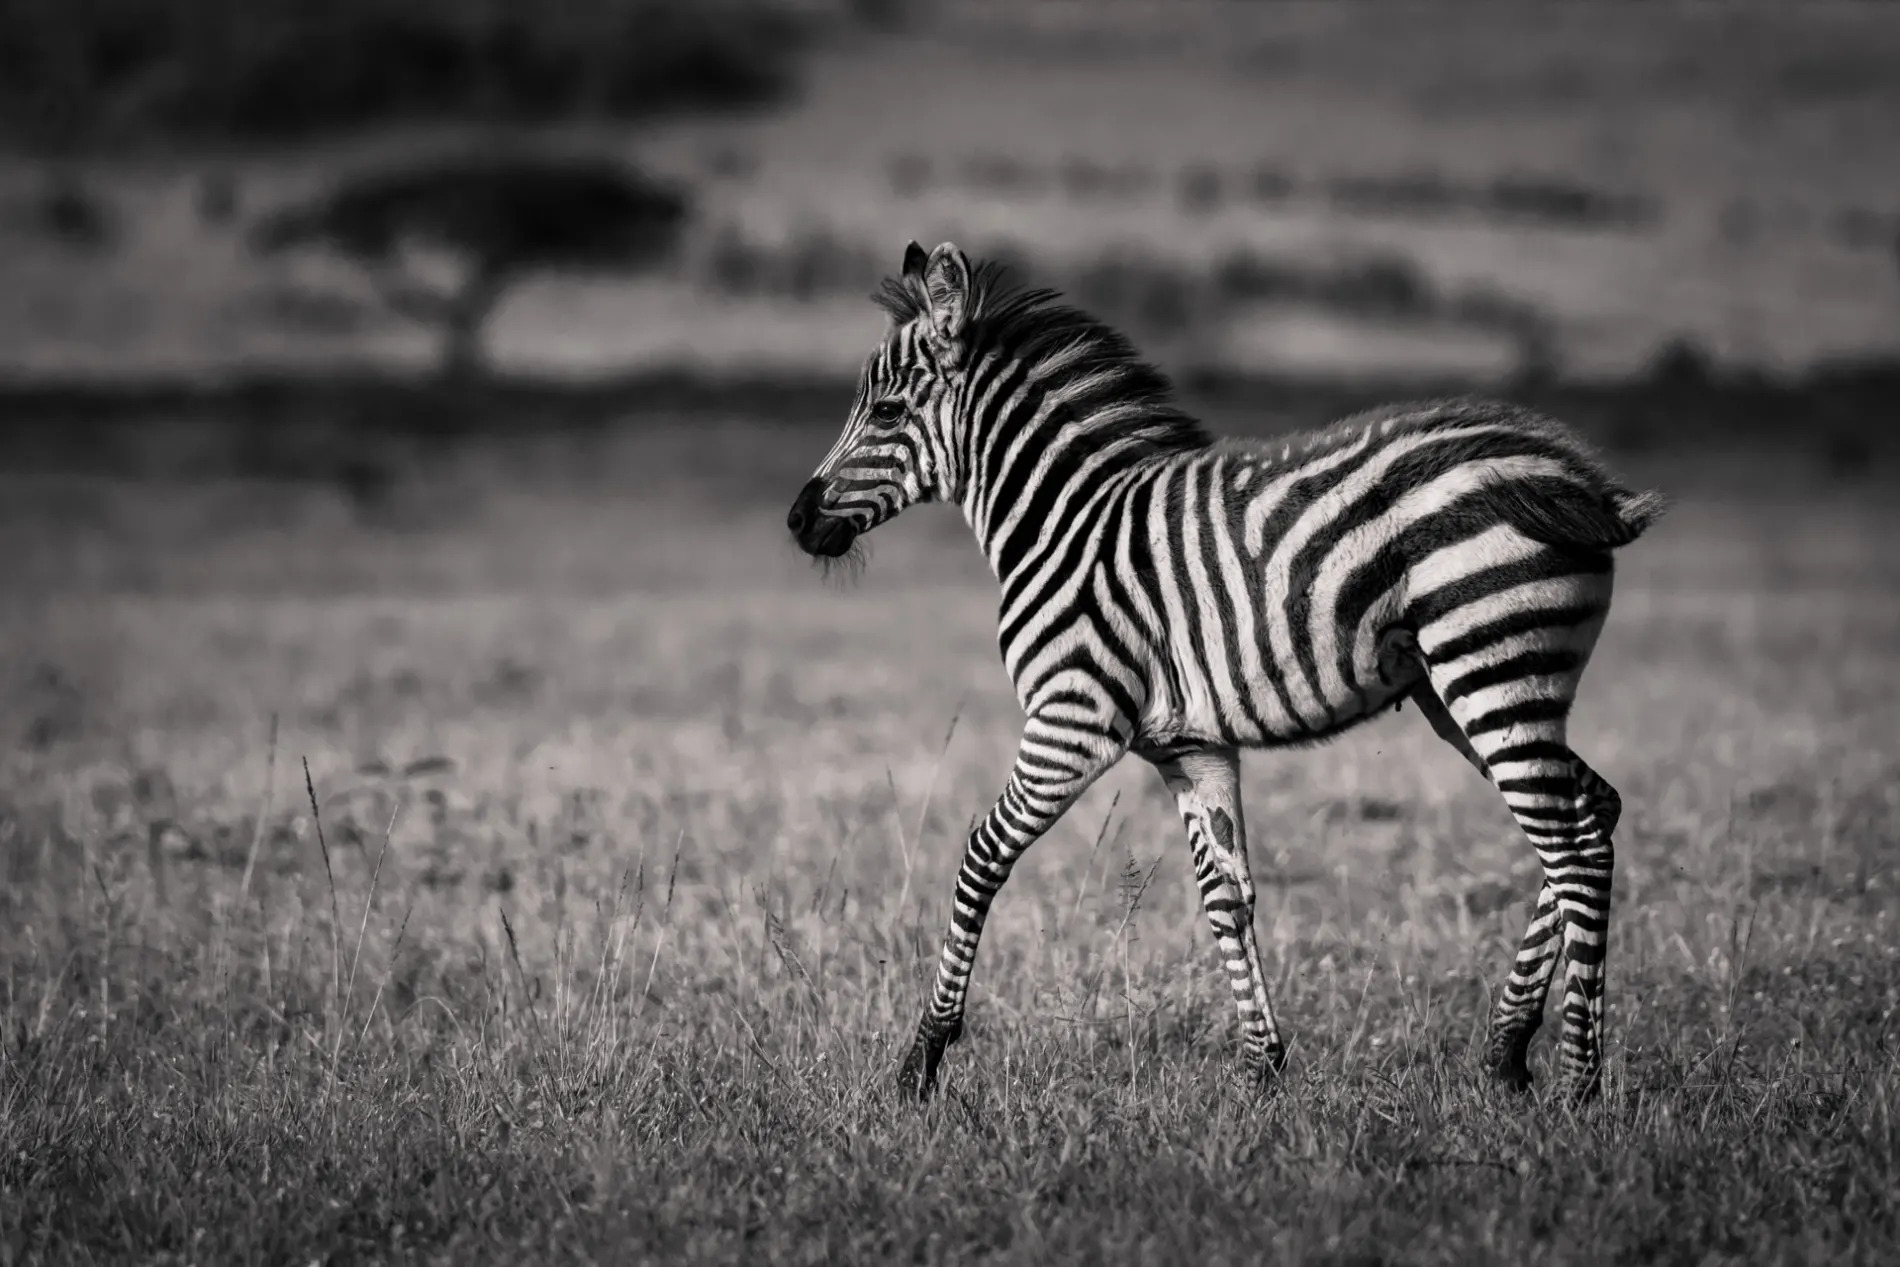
[897,718,1123,1100]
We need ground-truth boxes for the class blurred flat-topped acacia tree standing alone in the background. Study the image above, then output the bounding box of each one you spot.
[253,152,688,380]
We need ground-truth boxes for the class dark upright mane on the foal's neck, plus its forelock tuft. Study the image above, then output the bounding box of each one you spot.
[872,260,1212,450]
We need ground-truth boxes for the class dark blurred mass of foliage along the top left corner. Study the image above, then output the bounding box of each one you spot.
[0,0,806,145]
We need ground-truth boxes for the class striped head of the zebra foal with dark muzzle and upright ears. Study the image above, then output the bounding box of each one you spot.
[785,241,973,558]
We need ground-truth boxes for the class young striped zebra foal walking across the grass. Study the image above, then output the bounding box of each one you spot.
[787,243,1663,1098]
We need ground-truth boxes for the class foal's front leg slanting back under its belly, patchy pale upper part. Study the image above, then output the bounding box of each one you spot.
[1150,748,1286,1090]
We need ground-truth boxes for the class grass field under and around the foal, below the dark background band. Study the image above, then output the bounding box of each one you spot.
[0,422,1900,1267]
